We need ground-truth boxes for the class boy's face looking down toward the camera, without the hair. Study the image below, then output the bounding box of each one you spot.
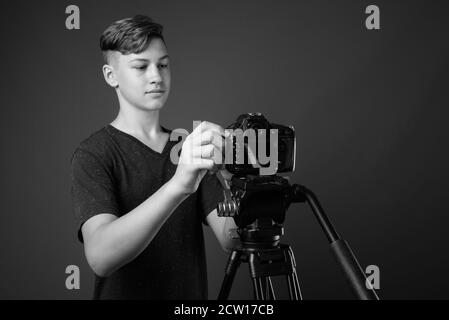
[108,38,170,110]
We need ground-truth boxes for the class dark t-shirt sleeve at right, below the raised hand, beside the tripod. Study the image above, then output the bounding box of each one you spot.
[198,173,224,225]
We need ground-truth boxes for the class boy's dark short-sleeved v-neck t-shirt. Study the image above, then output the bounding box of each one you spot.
[71,125,223,299]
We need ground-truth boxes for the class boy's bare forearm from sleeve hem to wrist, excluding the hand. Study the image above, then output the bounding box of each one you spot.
[81,179,188,277]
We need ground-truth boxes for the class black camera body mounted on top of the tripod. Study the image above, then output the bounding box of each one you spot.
[225,113,296,176]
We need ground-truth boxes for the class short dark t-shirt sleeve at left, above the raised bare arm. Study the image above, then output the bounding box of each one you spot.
[71,148,119,242]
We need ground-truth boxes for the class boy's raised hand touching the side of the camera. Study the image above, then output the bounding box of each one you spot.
[172,121,226,194]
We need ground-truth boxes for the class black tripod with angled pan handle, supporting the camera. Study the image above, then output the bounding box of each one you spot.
[217,175,379,300]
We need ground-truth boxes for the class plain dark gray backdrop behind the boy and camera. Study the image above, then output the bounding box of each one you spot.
[0,0,449,299]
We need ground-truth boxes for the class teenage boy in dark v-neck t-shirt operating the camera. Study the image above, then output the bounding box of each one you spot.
[71,15,235,299]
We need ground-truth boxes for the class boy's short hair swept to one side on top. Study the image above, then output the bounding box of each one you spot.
[100,15,165,63]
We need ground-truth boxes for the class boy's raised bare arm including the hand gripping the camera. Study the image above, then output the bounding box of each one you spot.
[81,122,224,277]
